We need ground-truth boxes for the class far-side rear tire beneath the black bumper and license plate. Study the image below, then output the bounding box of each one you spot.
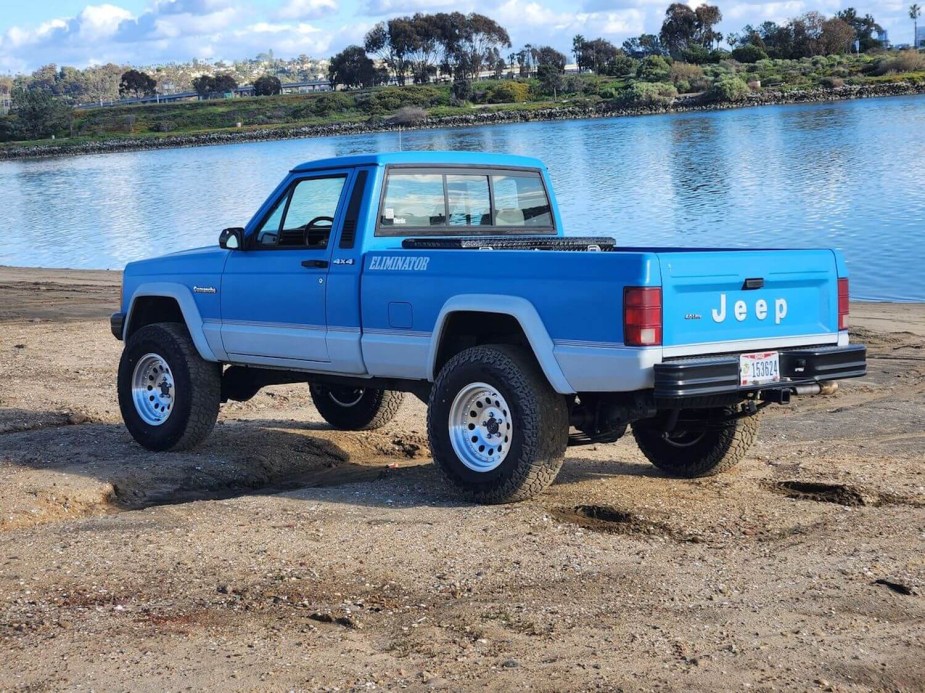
[633,407,758,479]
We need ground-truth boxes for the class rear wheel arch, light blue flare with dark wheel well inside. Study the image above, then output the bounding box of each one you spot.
[427,294,575,394]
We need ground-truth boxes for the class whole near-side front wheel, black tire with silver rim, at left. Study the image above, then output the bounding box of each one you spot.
[117,323,222,450]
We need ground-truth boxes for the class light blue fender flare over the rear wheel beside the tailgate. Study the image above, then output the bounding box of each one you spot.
[427,294,575,395]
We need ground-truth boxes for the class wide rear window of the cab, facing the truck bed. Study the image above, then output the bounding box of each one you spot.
[376,169,555,236]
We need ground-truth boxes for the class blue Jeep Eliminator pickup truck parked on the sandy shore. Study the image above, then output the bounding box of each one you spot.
[111,152,866,503]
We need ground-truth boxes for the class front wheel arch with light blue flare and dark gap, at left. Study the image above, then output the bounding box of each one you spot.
[124,282,218,361]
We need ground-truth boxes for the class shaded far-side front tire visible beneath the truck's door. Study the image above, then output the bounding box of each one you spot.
[309,385,405,431]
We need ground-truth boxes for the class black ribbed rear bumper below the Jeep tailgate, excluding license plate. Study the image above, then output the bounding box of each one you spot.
[655,344,867,400]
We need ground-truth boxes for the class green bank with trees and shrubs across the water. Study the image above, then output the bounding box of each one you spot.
[0,3,925,159]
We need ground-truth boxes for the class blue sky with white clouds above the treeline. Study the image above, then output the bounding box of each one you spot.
[0,0,912,74]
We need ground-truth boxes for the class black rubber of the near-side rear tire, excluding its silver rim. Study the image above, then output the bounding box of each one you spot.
[427,345,569,503]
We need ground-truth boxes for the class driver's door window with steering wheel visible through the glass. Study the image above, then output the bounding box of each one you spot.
[257,176,347,249]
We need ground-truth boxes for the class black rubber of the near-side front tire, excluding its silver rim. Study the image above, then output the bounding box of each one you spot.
[117,322,222,451]
